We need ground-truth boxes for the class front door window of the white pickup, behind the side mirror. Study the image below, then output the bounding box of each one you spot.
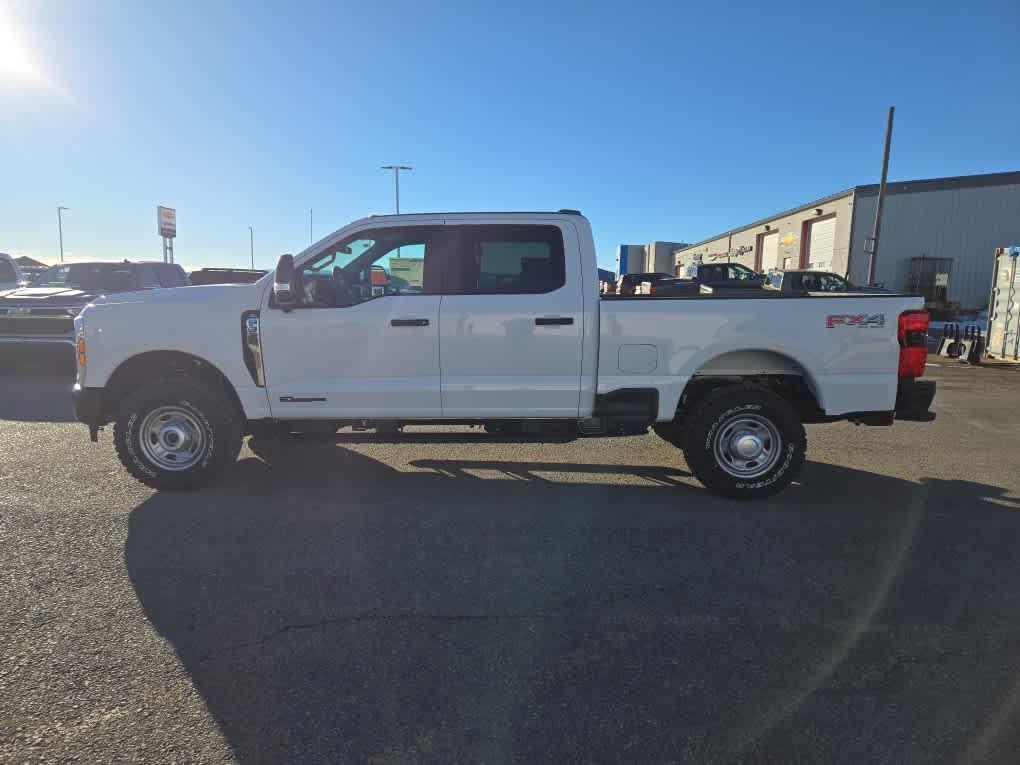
[301,227,431,308]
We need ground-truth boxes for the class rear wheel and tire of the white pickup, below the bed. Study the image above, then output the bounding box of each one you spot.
[683,384,808,499]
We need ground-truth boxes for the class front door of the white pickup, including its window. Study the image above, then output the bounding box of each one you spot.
[261,226,443,419]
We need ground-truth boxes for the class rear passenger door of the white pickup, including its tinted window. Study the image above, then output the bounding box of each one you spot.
[440,220,584,417]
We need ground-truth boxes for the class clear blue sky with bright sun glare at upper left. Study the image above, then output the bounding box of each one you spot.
[0,0,1020,267]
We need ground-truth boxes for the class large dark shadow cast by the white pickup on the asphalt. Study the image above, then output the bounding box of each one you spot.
[124,444,1020,763]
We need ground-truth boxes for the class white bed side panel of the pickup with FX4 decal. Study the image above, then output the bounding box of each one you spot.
[597,290,923,420]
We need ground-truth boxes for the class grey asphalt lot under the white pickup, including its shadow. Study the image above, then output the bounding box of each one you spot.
[0,354,1020,763]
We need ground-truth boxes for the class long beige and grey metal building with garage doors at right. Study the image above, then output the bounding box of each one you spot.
[673,172,1020,308]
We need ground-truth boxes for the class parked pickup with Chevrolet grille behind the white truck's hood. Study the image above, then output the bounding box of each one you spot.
[0,261,188,347]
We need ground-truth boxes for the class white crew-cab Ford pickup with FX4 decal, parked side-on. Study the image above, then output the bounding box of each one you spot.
[73,210,934,498]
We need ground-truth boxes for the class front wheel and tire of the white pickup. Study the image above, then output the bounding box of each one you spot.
[113,376,242,490]
